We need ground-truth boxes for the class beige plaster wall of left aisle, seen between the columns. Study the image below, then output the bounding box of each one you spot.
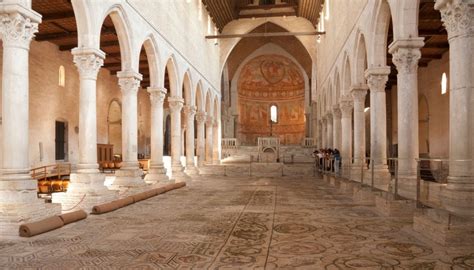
[0,41,150,167]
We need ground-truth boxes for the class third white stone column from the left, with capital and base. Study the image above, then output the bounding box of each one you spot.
[111,71,145,189]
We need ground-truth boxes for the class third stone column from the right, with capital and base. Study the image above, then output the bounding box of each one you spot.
[365,67,391,190]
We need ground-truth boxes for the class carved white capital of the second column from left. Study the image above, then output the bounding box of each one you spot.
[71,48,105,80]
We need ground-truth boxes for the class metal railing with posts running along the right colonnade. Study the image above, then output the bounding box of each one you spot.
[315,157,472,215]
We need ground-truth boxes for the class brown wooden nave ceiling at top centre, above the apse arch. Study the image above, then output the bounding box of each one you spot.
[202,0,324,32]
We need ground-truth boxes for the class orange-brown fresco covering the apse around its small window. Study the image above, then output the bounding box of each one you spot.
[238,54,305,145]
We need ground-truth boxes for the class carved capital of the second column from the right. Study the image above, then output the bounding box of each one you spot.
[389,38,425,74]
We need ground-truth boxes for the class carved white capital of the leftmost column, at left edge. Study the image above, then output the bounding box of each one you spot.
[0,5,41,50]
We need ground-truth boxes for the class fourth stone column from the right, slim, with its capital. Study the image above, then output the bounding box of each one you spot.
[351,86,367,181]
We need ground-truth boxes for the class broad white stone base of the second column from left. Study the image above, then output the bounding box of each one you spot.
[52,173,118,212]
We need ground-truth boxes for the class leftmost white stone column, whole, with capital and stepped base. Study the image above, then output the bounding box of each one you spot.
[0,8,61,236]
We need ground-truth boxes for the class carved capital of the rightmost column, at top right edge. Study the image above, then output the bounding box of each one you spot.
[435,0,474,39]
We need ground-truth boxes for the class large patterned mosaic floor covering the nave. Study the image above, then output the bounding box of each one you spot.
[0,174,474,270]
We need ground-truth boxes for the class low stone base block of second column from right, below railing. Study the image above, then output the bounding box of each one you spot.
[375,192,416,218]
